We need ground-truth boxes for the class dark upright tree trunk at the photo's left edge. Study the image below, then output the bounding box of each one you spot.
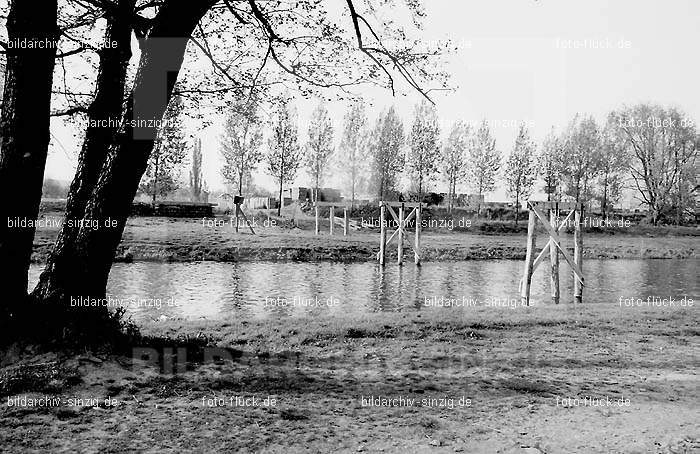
[0,0,59,318]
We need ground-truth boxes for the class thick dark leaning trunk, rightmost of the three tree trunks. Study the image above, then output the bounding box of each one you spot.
[35,0,214,312]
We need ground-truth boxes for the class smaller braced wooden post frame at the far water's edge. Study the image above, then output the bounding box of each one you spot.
[377,201,425,265]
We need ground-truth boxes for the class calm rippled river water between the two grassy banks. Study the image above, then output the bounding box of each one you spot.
[30,260,700,322]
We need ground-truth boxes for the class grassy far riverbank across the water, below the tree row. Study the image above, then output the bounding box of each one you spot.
[32,213,700,263]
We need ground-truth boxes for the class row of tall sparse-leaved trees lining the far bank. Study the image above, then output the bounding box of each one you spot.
[185,97,700,223]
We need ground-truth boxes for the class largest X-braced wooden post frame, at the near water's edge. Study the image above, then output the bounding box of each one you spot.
[520,201,584,305]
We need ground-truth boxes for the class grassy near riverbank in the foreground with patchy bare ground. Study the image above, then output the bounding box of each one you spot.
[0,304,700,454]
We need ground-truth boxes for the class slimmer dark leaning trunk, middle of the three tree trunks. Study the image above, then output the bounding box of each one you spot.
[35,0,135,306]
